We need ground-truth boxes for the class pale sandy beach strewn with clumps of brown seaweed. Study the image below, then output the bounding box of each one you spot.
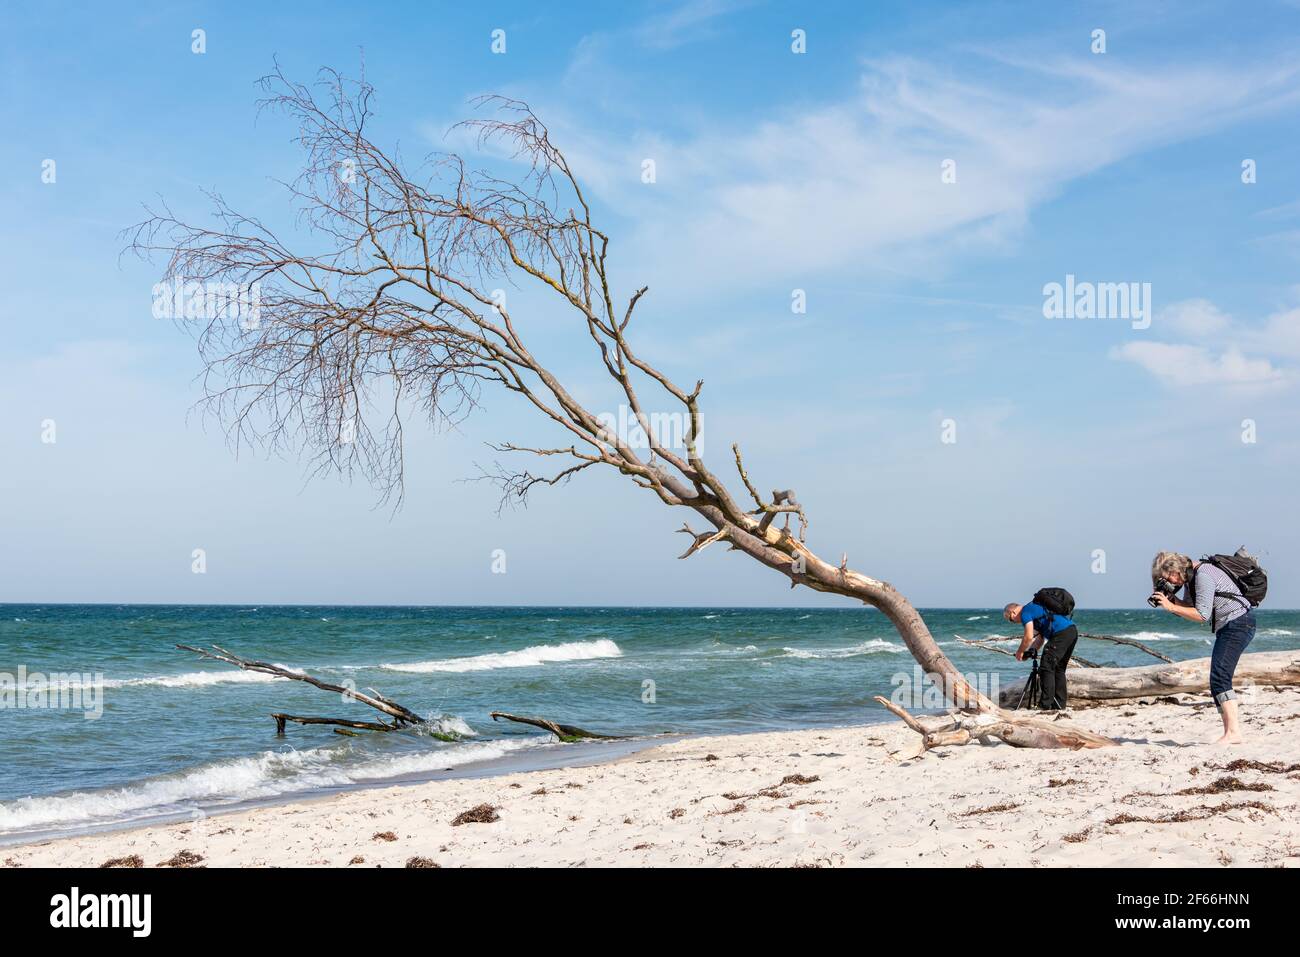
[0,689,1300,867]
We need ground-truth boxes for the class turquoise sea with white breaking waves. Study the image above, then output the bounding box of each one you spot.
[0,605,1300,841]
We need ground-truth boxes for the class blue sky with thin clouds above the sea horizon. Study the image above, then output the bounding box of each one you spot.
[0,0,1300,607]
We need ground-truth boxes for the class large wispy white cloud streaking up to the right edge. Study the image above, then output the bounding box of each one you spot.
[535,52,1300,287]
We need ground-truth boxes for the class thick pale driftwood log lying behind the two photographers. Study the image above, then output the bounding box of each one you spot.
[998,651,1300,705]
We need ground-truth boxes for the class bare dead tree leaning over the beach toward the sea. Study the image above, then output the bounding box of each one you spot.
[137,68,1110,748]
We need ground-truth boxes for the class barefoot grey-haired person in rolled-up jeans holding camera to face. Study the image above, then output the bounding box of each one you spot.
[1148,551,1255,744]
